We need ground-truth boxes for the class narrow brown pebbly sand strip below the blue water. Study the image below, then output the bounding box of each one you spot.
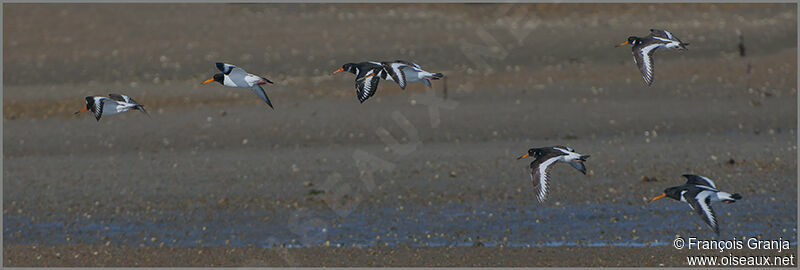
[3,245,797,267]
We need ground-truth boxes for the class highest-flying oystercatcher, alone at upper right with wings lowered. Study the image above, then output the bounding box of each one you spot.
[617,29,689,86]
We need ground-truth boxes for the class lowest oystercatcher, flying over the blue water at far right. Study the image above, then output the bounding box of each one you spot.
[650,174,742,235]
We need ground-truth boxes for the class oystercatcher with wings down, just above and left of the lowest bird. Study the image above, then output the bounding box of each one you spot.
[517,145,589,202]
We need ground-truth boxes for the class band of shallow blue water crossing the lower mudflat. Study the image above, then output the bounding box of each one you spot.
[3,193,797,247]
